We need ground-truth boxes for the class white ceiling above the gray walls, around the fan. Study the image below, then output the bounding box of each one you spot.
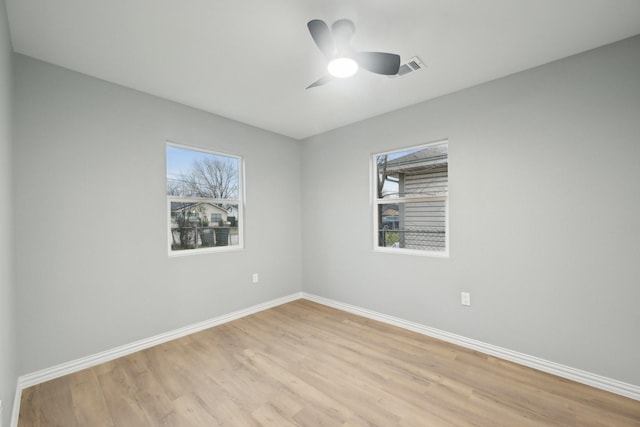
[6,0,640,139]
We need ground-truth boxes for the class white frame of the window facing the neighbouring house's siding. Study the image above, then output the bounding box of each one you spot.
[371,139,451,258]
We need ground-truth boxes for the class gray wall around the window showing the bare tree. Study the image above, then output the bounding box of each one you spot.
[13,55,301,374]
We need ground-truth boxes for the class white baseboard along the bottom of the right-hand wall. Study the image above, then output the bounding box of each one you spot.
[302,292,640,400]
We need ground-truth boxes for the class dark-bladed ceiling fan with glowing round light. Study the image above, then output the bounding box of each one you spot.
[307,19,400,89]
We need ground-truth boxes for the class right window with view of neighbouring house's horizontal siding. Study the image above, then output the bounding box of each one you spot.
[372,141,449,256]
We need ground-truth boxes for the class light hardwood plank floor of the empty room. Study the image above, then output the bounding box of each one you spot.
[19,300,640,427]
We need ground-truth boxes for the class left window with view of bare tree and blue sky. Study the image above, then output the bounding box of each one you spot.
[167,144,243,255]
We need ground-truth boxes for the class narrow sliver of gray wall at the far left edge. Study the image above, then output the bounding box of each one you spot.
[0,0,17,425]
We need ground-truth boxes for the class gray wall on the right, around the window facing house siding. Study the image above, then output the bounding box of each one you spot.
[302,37,640,385]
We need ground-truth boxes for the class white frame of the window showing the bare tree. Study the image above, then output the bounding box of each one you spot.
[165,141,245,257]
